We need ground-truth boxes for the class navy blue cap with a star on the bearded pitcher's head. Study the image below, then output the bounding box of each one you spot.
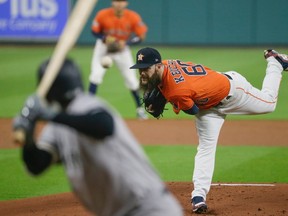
[130,47,162,69]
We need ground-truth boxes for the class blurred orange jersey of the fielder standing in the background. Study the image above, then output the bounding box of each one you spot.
[91,8,147,41]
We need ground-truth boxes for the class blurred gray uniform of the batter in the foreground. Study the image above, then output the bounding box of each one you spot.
[37,93,182,216]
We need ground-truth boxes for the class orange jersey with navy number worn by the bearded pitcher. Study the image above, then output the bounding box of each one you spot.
[161,60,230,114]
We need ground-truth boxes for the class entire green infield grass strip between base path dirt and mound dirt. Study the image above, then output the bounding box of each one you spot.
[0,145,288,200]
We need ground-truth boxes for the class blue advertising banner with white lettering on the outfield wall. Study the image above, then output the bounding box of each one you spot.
[0,0,70,41]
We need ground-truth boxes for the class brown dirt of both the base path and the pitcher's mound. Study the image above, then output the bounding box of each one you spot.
[0,119,288,216]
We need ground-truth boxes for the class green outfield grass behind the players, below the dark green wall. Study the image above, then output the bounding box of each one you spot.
[0,46,288,119]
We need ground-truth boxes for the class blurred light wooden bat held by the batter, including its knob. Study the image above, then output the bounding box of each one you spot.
[13,0,97,144]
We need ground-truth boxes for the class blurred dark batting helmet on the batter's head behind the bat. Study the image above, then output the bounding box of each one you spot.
[38,59,84,108]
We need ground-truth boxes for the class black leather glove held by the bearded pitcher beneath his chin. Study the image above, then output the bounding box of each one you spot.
[143,87,167,119]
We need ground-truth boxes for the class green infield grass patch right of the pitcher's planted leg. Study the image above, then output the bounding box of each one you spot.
[214,146,288,183]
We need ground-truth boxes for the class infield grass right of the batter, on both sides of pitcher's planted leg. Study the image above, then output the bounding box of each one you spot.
[145,145,288,183]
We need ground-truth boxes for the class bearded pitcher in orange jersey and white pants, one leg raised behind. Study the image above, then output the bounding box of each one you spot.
[131,47,288,213]
